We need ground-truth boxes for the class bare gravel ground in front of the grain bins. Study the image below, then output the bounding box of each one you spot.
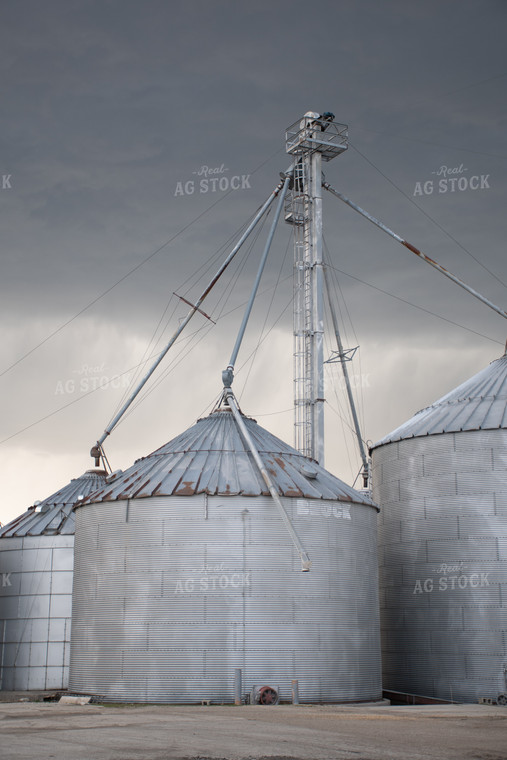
[0,694,507,760]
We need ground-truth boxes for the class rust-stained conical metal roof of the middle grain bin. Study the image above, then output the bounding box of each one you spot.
[85,409,371,504]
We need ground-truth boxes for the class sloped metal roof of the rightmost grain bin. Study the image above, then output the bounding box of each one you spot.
[372,355,507,449]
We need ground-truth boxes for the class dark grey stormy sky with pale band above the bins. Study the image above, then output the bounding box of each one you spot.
[0,0,507,523]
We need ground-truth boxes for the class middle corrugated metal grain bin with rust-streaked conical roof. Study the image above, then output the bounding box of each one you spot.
[69,409,381,703]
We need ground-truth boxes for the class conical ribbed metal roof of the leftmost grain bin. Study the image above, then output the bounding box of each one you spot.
[0,470,107,539]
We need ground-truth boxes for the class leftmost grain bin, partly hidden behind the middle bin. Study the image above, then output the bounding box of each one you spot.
[0,470,106,691]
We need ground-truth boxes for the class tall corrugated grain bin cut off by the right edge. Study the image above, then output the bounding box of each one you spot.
[372,356,507,703]
